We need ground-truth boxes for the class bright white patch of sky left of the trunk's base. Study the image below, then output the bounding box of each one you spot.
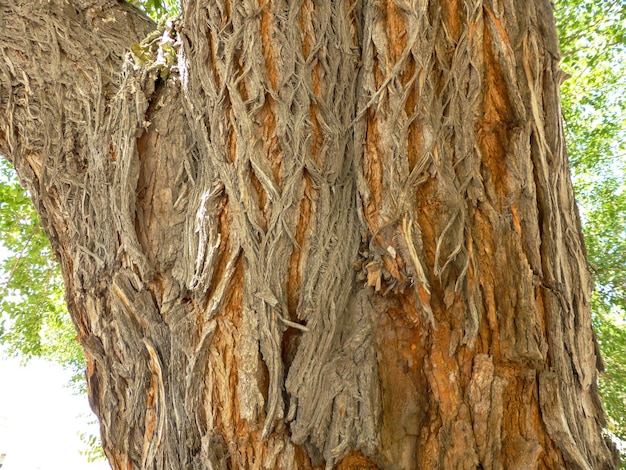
[0,351,110,470]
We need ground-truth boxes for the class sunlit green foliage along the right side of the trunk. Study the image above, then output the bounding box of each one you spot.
[556,0,626,458]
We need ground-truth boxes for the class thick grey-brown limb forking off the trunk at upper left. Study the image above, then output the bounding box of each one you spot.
[0,0,154,182]
